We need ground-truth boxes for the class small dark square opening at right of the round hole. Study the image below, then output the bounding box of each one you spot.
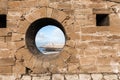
[96,14,110,26]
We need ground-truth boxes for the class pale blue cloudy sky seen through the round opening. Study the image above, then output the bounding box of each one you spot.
[35,25,65,47]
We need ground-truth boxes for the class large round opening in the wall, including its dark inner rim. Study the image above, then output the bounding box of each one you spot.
[26,18,66,55]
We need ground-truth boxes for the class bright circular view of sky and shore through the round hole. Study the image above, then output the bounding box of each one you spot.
[35,25,65,54]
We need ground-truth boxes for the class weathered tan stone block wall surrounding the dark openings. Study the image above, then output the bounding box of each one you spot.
[0,0,120,80]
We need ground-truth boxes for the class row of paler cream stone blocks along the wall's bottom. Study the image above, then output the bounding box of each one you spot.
[0,73,120,80]
